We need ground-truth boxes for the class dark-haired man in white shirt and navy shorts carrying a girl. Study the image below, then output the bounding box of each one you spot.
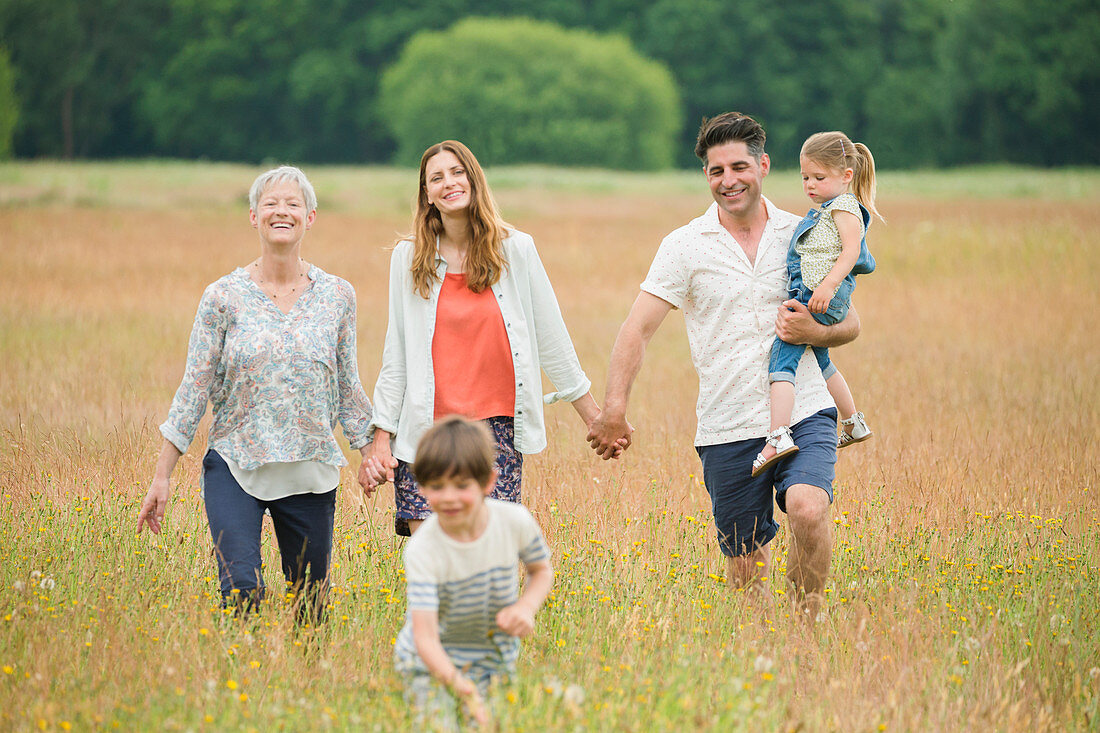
[589,112,859,619]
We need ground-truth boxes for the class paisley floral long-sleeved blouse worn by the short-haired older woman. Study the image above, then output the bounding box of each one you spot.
[161,266,373,470]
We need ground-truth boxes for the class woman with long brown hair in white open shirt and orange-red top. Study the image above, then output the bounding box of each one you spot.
[360,140,625,535]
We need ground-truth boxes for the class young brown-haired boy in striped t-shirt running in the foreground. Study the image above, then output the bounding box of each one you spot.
[394,416,553,724]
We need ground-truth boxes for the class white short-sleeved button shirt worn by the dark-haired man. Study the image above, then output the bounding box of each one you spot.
[641,199,833,446]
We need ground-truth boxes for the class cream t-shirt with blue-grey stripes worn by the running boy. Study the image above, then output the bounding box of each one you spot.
[394,499,550,672]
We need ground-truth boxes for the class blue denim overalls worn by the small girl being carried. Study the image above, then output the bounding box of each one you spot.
[768,198,875,382]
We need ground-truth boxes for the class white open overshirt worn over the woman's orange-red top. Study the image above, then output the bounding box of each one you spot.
[370,230,592,462]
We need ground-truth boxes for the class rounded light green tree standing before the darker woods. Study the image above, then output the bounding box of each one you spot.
[378,19,681,168]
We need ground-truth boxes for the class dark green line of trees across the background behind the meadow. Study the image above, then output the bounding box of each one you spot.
[0,0,1100,167]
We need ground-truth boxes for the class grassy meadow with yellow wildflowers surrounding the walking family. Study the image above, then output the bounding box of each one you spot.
[0,163,1100,731]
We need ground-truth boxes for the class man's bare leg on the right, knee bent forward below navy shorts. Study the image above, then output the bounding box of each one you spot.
[787,483,833,621]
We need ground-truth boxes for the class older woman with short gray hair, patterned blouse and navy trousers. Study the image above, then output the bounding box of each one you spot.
[138,166,372,620]
